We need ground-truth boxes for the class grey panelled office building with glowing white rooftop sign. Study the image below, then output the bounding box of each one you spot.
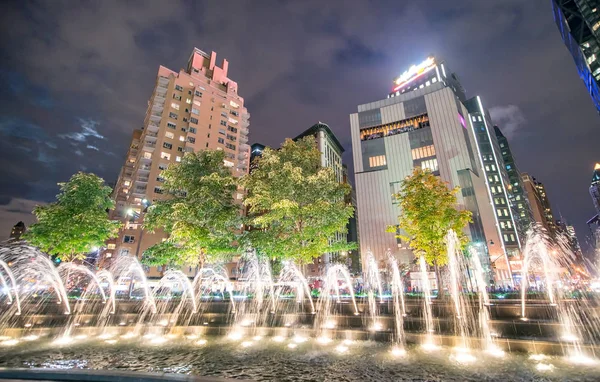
[350,57,517,285]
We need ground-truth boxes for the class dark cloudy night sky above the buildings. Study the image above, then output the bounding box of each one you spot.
[0,0,600,254]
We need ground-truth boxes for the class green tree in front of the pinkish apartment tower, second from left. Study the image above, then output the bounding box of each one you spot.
[142,150,242,265]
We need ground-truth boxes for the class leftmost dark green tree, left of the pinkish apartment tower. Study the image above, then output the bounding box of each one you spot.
[23,172,121,261]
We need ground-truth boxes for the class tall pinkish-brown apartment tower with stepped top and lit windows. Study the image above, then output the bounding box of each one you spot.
[103,48,250,277]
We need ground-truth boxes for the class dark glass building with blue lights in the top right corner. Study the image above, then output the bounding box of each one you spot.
[552,0,600,112]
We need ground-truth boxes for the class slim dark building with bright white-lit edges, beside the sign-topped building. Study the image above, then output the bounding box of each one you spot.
[465,96,521,276]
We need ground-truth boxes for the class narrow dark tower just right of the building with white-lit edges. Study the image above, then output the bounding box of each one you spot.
[494,126,533,242]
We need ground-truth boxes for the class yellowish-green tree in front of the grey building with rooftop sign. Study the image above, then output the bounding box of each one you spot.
[388,167,471,286]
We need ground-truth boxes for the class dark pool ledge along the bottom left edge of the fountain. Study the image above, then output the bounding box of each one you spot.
[0,368,244,382]
